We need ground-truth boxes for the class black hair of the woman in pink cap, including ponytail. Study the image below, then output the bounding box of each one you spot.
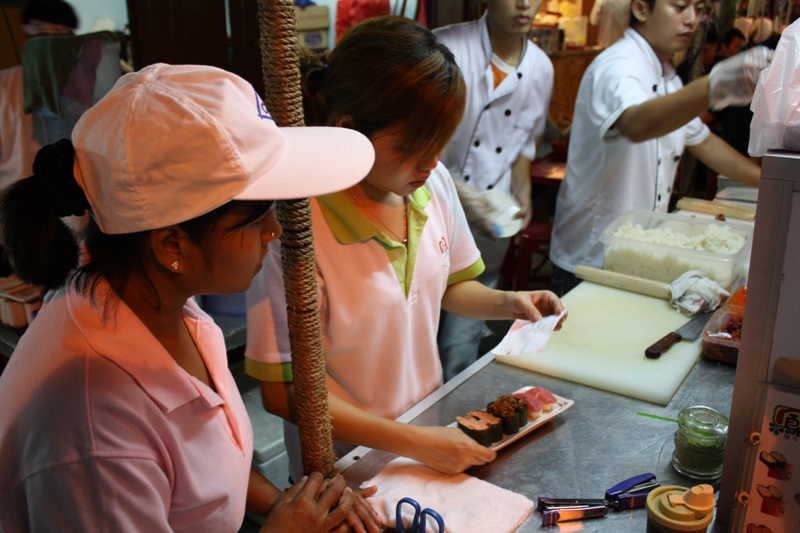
[0,139,272,305]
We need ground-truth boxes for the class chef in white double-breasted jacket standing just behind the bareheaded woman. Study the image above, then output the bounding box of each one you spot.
[434,0,553,380]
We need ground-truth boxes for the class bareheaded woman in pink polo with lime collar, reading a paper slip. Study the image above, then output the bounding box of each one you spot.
[245,16,562,479]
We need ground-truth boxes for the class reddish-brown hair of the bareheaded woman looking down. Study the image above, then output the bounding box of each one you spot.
[300,15,466,163]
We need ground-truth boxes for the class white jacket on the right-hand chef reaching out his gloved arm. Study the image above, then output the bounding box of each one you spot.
[550,28,710,272]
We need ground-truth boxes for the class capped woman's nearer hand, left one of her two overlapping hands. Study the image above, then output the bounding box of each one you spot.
[259,472,354,533]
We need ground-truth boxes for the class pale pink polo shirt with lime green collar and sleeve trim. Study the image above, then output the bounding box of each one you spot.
[245,164,483,476]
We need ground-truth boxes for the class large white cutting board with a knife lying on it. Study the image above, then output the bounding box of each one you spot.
[496,281,702,405]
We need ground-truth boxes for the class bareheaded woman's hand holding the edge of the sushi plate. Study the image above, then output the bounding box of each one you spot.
[404,426,497,474]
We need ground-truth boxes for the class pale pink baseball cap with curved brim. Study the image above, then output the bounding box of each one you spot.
[72,64,375,234]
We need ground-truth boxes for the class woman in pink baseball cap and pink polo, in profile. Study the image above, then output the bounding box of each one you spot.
[0,64,378,533]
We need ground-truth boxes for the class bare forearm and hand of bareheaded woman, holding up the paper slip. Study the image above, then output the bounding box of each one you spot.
[442,280,566,322]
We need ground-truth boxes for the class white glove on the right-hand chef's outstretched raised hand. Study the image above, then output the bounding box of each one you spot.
[708,46,775,111]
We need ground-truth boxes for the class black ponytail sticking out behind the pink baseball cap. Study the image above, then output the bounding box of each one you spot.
[0,139,89,289]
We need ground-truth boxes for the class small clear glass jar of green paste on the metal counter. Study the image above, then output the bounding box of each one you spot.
[672,405,728,481]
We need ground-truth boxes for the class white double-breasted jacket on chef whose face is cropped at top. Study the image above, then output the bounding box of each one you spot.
[434,13,553,196]
